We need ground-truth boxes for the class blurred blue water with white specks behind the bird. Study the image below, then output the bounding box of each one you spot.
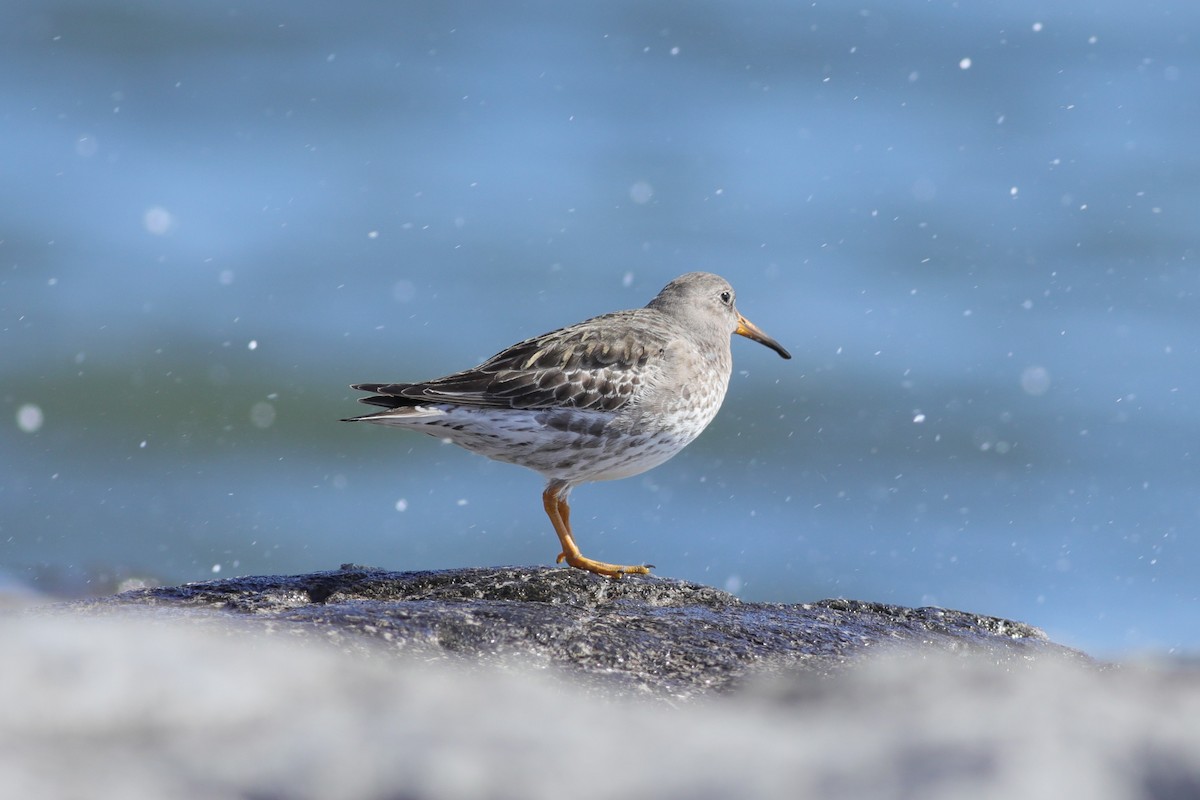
[0,0,1200,655]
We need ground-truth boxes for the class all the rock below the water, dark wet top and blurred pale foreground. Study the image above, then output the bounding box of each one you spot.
[0,569,1200,800]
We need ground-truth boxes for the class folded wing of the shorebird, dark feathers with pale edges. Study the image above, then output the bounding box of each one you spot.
[354,308,668,411]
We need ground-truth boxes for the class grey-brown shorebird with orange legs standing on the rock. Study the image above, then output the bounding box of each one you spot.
[343,272,792,578]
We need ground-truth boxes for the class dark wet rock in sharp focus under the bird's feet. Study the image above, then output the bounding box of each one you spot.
[73,565,1085,698]
